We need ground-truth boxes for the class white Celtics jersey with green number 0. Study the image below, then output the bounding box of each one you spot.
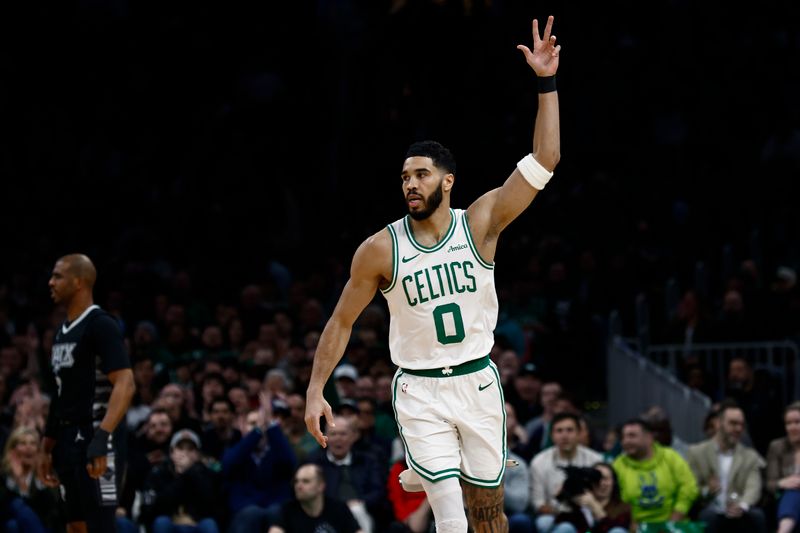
[381,209,497,370]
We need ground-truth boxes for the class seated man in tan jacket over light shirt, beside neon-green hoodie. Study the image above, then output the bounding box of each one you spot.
[687,403,767,533]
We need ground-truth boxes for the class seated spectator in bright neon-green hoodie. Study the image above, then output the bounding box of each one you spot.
[614,419,698,524]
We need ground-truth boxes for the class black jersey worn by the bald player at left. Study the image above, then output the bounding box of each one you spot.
[49,305,131,427]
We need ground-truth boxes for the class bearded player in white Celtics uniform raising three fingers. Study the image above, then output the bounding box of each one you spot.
[305,17,561,533]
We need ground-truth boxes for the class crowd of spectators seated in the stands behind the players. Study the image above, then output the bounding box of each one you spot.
[0,258,800,533]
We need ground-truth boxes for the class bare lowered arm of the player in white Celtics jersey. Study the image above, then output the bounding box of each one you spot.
[305,231,392,448]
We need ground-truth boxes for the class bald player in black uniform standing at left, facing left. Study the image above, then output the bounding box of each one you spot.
[39,254,135,533]
